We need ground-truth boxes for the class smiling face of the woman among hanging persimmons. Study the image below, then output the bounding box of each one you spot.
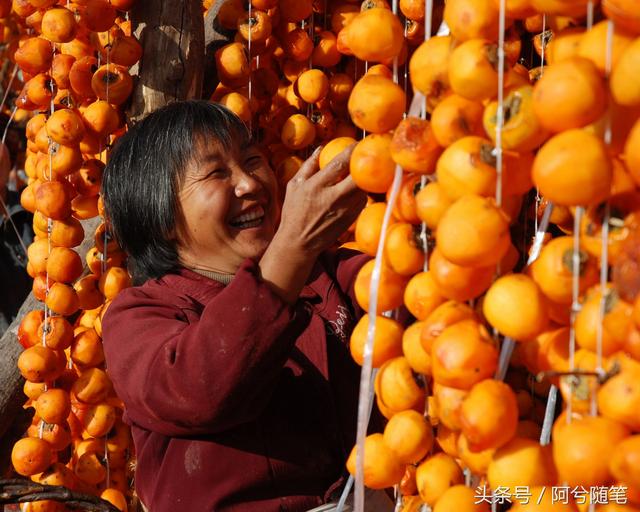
[178,134,280,273]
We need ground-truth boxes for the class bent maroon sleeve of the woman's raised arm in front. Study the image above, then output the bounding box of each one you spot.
[103,263,308,436]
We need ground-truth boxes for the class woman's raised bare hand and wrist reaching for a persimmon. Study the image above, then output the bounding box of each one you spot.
[259,146,367,304]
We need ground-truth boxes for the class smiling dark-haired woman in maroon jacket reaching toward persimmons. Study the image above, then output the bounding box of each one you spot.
[102,101,393,512]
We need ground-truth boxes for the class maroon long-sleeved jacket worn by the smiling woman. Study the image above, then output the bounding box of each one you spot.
[103,250,367,512]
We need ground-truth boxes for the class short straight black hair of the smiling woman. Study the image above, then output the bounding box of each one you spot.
[102,100,249,285]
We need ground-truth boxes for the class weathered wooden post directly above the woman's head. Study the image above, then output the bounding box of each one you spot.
[128,0,204,123]
